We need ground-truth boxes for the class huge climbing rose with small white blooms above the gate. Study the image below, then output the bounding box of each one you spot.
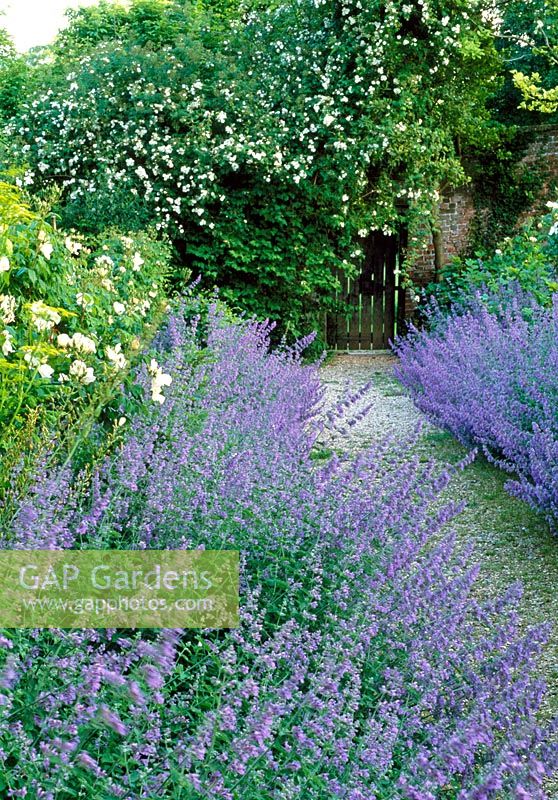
[4,0,497,334]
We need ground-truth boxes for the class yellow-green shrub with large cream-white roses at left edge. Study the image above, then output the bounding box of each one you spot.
[0,184,169,427]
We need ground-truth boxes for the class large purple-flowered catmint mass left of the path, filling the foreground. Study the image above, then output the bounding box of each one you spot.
[0,310,558,800]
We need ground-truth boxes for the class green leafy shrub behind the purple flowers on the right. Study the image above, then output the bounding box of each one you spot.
[423,202,558,308]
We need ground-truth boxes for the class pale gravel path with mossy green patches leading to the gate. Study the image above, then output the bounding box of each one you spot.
[322,354,558,784]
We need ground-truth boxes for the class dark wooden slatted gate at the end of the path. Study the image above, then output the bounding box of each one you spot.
[326,231,405,350]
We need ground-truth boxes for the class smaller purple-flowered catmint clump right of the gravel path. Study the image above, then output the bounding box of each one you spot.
[396,286,558,524]
